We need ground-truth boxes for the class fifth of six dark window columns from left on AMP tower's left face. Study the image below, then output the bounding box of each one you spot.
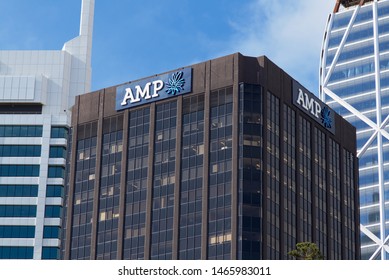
[178,93,204,260]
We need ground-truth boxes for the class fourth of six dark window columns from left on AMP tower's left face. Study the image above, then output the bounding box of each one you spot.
[150,101,178,260]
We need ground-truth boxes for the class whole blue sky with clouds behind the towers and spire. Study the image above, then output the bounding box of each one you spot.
[0,0,336,94]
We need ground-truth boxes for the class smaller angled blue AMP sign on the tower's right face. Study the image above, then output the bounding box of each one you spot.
[293,80,335,134]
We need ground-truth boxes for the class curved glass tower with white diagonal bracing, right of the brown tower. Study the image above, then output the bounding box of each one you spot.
[320,0,389,260]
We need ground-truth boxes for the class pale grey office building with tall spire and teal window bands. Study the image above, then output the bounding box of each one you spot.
[0,0,94,259]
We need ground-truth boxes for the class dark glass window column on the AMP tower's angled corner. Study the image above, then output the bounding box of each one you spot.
[238,84,264,259]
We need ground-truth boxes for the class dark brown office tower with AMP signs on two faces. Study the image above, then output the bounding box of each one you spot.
[62,53,360,260]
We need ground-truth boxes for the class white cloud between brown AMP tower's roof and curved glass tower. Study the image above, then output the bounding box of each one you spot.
[226,0,335,94]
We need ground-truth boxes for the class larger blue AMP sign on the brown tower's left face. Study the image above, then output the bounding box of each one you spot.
[116,68,192,111]
